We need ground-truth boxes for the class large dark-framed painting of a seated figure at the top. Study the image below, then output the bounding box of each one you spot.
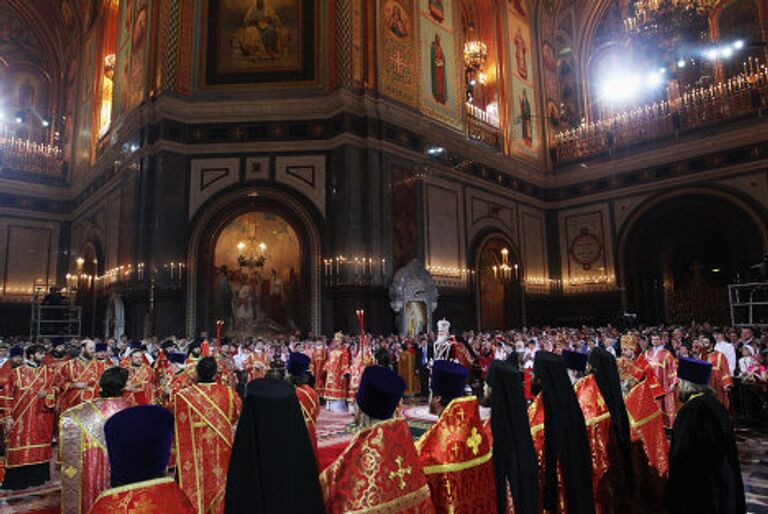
[202,0,318,85]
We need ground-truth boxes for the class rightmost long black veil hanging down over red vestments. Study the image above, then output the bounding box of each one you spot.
[588,346,635,495]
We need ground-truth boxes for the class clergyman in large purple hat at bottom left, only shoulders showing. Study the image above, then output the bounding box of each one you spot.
[91,405,196,514]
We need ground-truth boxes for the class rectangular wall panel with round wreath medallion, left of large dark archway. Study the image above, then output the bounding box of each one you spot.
[565,211,608,286]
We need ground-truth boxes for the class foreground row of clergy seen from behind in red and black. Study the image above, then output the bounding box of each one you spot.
[7,338,745,514]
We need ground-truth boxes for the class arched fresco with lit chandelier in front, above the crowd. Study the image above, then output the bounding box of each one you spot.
[211,212,302,337]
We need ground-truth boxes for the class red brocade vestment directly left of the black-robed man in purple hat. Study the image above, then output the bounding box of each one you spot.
[624,380,669,512]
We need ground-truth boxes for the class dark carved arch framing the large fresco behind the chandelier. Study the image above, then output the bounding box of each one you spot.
[186,186,322,335]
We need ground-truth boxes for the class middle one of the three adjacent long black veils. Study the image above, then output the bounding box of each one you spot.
[533,351,595,514]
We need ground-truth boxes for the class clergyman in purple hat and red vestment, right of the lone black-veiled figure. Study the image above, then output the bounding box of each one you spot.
[320,366,435,514]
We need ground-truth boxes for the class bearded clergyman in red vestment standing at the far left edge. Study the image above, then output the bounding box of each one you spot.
[0,344,56,490]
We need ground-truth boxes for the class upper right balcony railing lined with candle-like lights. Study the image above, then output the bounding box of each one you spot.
[553,68,768,163]
